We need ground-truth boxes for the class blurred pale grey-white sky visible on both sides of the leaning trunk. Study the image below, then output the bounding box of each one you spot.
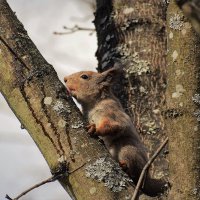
[0,0,97,200]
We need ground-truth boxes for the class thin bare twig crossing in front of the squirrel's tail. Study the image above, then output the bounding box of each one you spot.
[131,137,169,200]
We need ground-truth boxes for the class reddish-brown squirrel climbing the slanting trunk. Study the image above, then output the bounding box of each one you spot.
[64,66,166,197]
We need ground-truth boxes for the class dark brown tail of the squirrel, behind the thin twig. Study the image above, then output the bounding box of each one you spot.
[141,177,168,197]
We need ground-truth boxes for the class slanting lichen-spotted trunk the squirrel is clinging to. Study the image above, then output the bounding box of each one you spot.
[0,0,133,200]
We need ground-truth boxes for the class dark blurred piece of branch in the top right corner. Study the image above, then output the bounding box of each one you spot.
[176,0,200,34]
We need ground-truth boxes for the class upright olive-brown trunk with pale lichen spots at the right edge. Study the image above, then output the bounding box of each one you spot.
[165,0,200,200]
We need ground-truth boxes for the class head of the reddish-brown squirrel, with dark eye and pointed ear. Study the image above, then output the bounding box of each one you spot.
[64,66,122,105]
